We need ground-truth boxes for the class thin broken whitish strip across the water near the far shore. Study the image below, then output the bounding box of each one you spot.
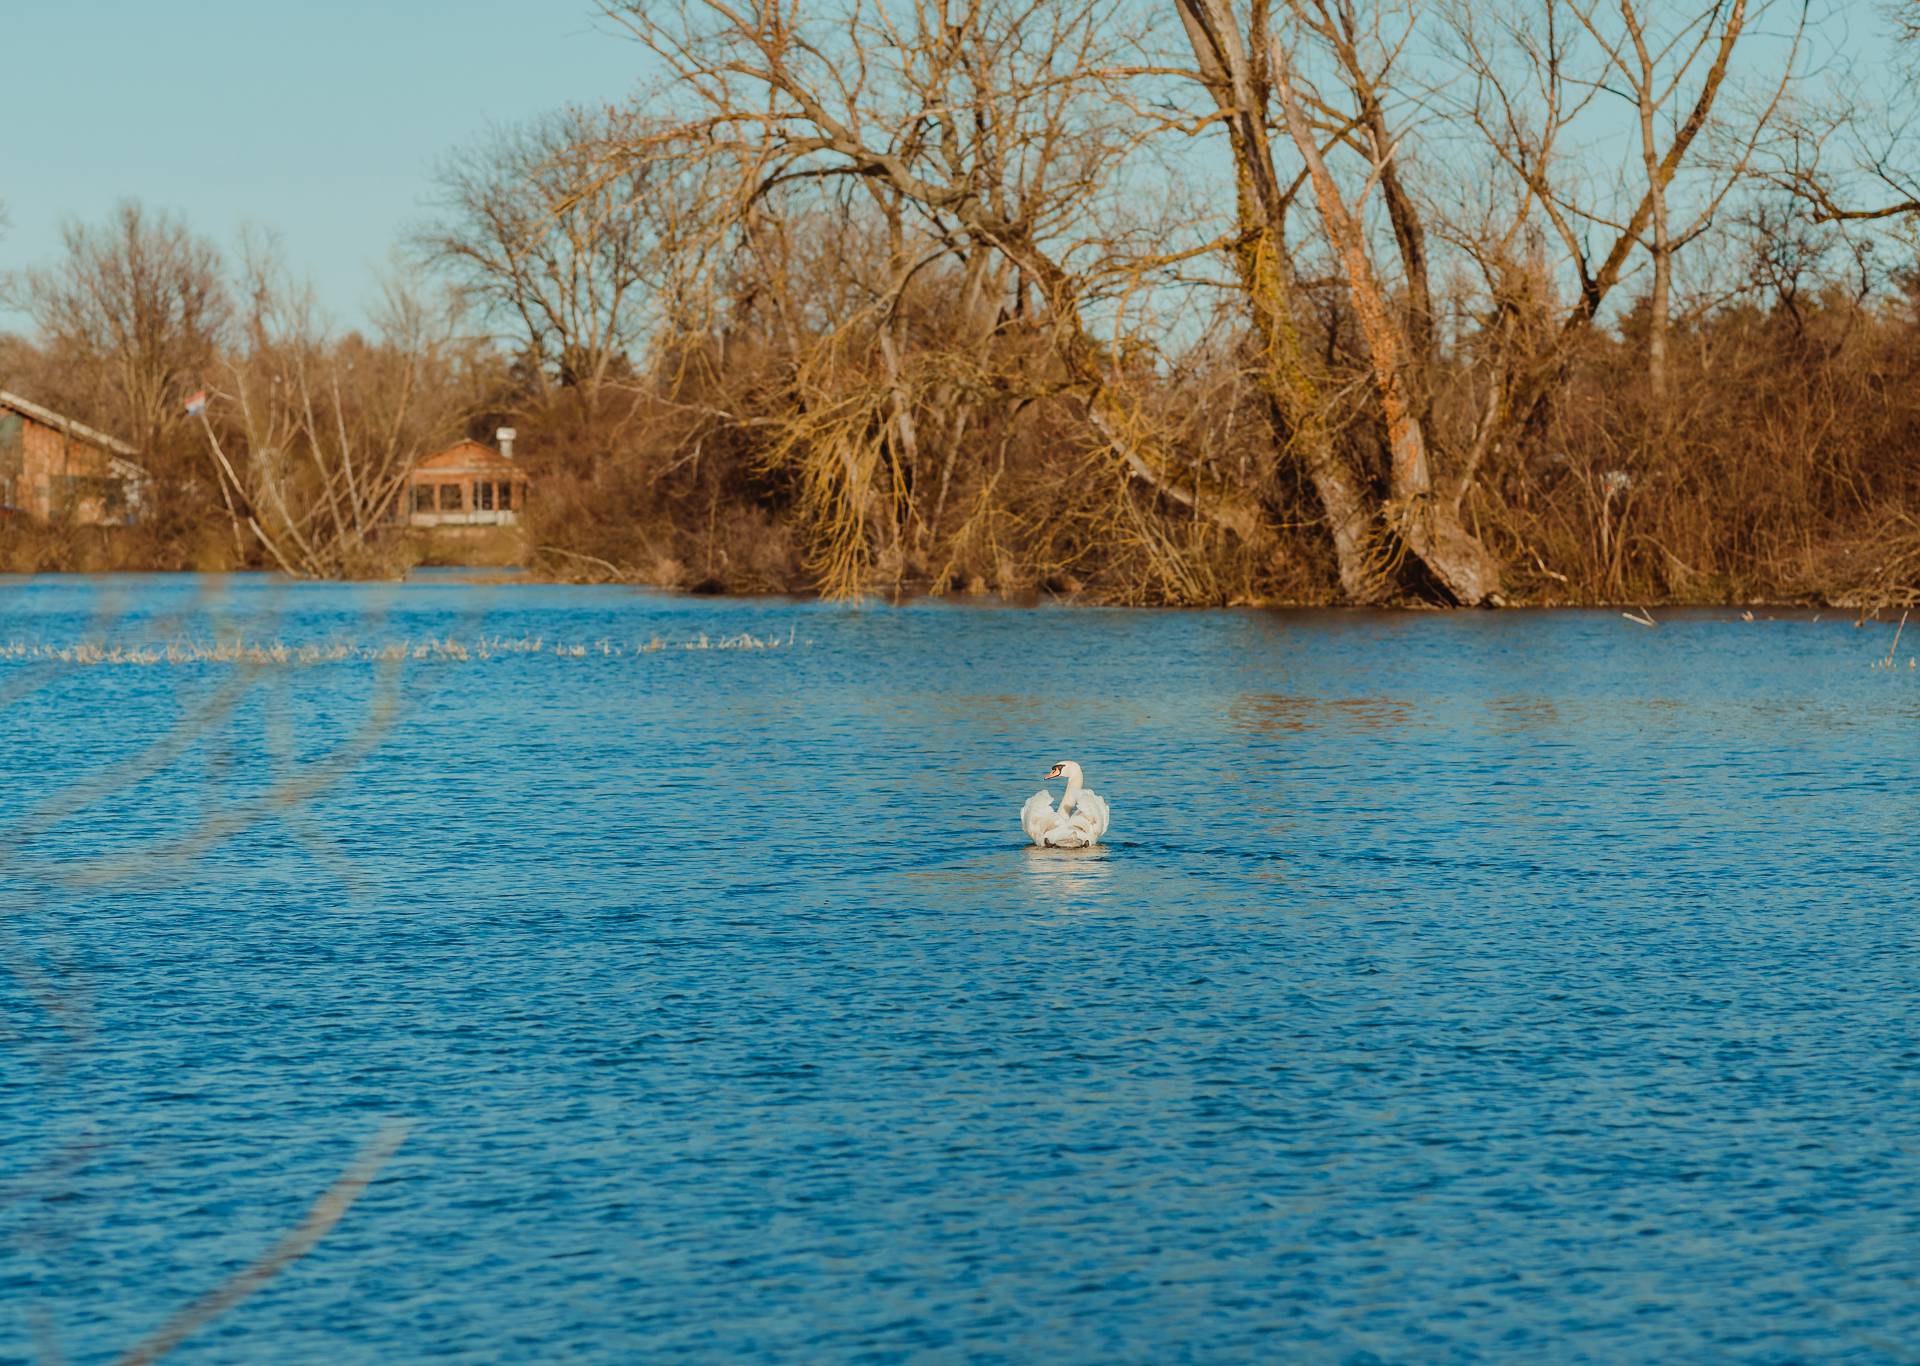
[0,630,814,667]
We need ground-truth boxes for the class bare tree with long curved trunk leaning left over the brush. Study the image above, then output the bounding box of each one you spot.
[609,0,1273,580]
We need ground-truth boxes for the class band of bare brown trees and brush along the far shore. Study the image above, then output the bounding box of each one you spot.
[0,0,1920,605]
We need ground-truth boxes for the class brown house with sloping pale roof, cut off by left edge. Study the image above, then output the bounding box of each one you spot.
[0,390,152,526]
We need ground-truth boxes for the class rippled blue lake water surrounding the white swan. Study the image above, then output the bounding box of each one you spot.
[0,578,1920,1364]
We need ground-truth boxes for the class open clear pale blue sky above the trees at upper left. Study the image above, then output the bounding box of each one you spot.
[0,0,645,330]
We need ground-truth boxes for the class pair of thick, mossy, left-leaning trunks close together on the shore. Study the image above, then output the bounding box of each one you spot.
[1179,0,1500,603]
